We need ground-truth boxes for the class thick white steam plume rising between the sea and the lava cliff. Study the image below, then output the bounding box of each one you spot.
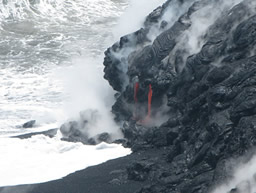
[56,58,121,138]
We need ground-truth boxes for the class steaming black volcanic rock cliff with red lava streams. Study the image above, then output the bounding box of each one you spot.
[104,0,256,193]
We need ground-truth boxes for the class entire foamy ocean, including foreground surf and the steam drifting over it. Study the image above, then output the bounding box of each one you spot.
[0,0,134,186]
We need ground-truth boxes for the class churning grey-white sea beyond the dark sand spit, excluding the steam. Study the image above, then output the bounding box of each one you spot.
[0,0,128,134]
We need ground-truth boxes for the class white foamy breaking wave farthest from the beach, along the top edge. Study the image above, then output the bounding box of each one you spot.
[0,0,125,25]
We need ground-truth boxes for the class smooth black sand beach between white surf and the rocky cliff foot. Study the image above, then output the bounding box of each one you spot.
[0,149,163,193]
